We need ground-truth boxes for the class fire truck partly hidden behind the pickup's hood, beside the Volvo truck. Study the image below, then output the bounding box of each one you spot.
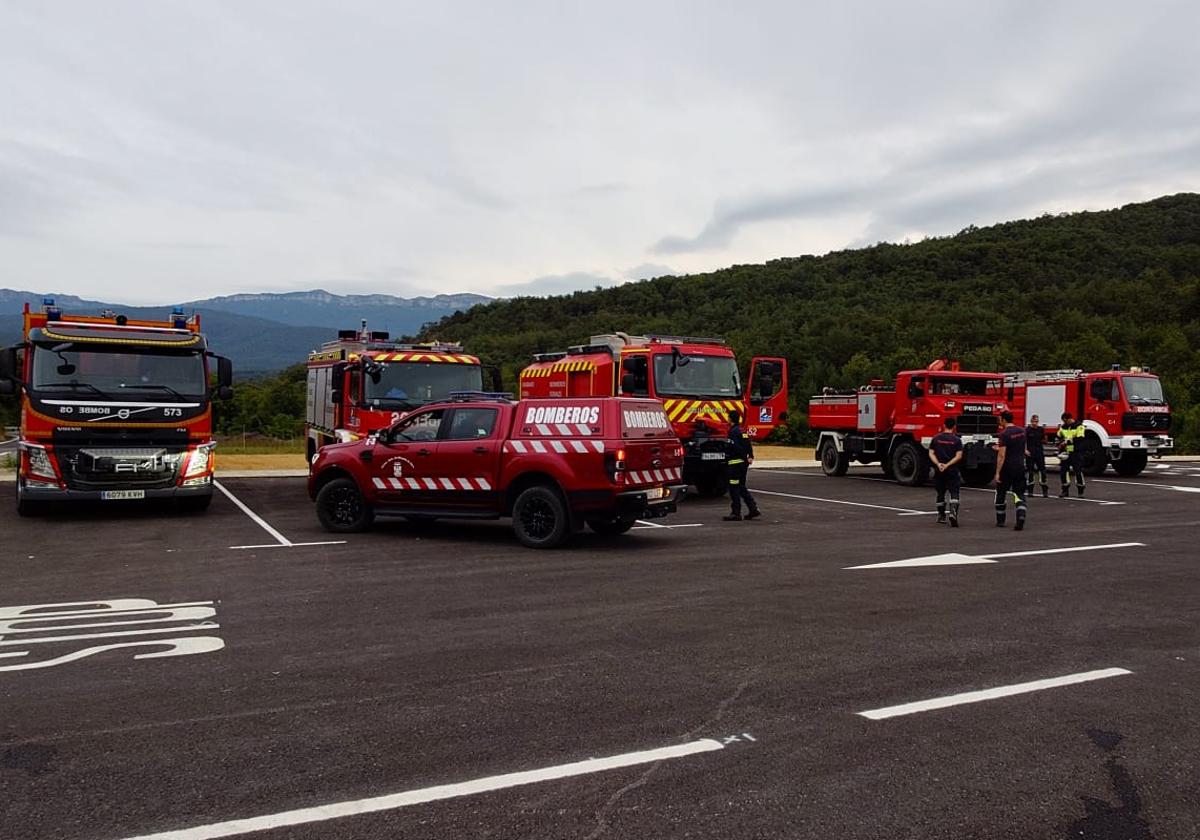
[305,320,500,463]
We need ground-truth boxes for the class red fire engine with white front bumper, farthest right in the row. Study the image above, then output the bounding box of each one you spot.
[1004,365,1175,475]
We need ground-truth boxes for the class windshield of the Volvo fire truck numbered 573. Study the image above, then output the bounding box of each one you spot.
[31,343,208,400]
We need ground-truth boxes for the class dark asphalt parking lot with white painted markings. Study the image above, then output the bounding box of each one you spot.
[0,462,1200,840]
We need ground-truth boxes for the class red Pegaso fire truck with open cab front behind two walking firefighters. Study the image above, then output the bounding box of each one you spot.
[809,359,1008,486]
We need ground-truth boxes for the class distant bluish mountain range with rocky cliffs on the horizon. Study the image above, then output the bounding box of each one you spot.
[0,289,491,376]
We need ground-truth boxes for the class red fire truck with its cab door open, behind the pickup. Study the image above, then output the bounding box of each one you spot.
[521,332,787,496]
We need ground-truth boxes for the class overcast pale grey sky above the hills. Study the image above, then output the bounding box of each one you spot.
[0,0,1200,302]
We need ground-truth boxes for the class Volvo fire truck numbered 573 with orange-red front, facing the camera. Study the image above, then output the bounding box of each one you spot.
[0,298,233,516]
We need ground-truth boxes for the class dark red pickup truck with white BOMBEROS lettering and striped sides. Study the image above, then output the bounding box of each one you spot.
[308,392,685,548]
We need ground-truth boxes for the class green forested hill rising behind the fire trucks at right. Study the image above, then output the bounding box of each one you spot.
[424,193,1200,451]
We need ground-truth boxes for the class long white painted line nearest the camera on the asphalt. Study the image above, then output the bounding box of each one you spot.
[117,738,725,840]
